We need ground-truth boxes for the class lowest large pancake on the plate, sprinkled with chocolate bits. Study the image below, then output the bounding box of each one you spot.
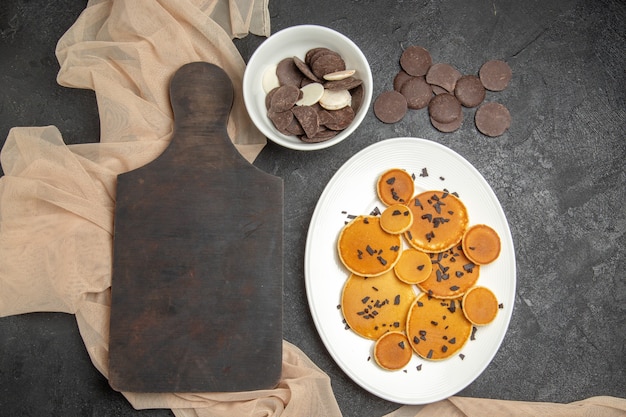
[406,294,472,360]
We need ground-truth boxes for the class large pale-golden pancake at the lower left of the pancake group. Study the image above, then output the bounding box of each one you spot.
[341,271,416,340]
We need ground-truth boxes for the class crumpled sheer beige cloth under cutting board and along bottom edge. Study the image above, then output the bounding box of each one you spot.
[0,0,626,417]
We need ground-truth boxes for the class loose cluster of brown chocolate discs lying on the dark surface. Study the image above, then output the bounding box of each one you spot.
[374,46,512,137]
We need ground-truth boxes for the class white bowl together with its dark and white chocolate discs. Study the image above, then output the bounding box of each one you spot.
[243,25,373,150]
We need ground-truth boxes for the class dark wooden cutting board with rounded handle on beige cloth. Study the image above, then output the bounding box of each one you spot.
[109,62,283,392]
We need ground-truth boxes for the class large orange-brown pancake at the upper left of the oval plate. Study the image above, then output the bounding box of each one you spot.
[337,216,402,277]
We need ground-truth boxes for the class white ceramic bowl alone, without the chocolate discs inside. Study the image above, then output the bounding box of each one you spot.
[243,25,373,151]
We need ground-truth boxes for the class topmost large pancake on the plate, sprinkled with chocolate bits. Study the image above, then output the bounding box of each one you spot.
[404,191,469,252]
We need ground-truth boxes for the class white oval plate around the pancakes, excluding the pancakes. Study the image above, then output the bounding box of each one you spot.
[304,138,516,404]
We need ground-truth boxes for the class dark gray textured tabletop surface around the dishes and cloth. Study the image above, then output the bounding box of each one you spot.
[0,0,626,417]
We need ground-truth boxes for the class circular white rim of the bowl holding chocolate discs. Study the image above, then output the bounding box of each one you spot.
[242,24,373,151]
